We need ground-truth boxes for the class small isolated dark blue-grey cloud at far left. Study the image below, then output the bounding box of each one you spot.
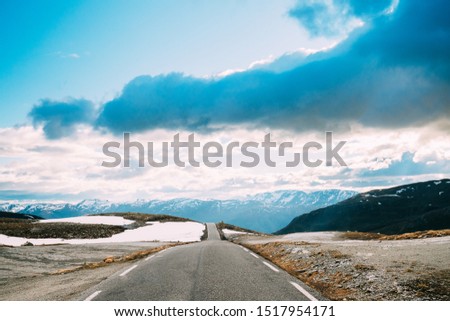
[29,99,95,139]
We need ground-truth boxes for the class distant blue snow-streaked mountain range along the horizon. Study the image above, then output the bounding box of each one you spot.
[0,190,357,232]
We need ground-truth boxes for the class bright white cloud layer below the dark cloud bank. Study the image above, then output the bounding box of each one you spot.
[0,122,450,201]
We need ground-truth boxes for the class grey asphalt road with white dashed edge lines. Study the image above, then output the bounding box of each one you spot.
[82,223,320,301]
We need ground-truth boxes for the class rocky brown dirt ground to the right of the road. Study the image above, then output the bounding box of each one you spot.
[232,232,450,300]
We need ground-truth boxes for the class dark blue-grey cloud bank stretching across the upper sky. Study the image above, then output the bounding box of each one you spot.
[30,0,450,139]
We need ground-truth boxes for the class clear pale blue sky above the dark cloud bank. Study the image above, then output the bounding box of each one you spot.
[0,0,332,126]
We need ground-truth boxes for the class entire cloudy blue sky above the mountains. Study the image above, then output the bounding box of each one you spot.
[0,0,450,200]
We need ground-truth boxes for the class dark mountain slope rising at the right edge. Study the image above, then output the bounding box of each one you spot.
[276,179,450,234]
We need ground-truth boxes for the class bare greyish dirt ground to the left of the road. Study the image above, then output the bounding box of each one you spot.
[0,242,168,301]
